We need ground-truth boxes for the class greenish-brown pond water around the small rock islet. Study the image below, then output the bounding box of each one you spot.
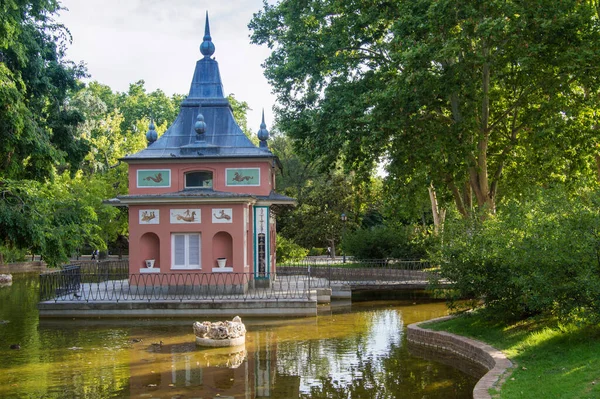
[0,275,483,399]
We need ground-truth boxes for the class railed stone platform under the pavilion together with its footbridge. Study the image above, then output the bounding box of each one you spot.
[38,261,440,318]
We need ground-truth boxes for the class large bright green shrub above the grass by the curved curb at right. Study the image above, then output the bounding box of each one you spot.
[435,187,600,324]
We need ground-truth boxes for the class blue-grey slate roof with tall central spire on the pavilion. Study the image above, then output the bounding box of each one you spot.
[123,14,274,161]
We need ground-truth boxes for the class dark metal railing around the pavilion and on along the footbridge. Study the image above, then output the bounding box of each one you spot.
[40,259,437,302]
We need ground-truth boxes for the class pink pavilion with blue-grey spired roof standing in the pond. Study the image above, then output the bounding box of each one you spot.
[110,15,295,279]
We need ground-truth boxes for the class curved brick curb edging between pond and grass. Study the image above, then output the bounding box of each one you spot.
[407,316,513,399]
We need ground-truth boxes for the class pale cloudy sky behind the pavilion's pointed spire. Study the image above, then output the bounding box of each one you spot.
[58,0,275,132]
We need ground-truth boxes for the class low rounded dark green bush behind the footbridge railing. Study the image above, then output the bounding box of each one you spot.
[342,226,426,260]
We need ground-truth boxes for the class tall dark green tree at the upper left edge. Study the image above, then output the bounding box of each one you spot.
[0,0,87,179]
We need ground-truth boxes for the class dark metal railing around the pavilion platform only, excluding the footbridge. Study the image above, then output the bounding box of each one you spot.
[40,271,314,302]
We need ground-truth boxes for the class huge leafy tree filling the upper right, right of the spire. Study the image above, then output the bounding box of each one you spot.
[249,0,600,217]
